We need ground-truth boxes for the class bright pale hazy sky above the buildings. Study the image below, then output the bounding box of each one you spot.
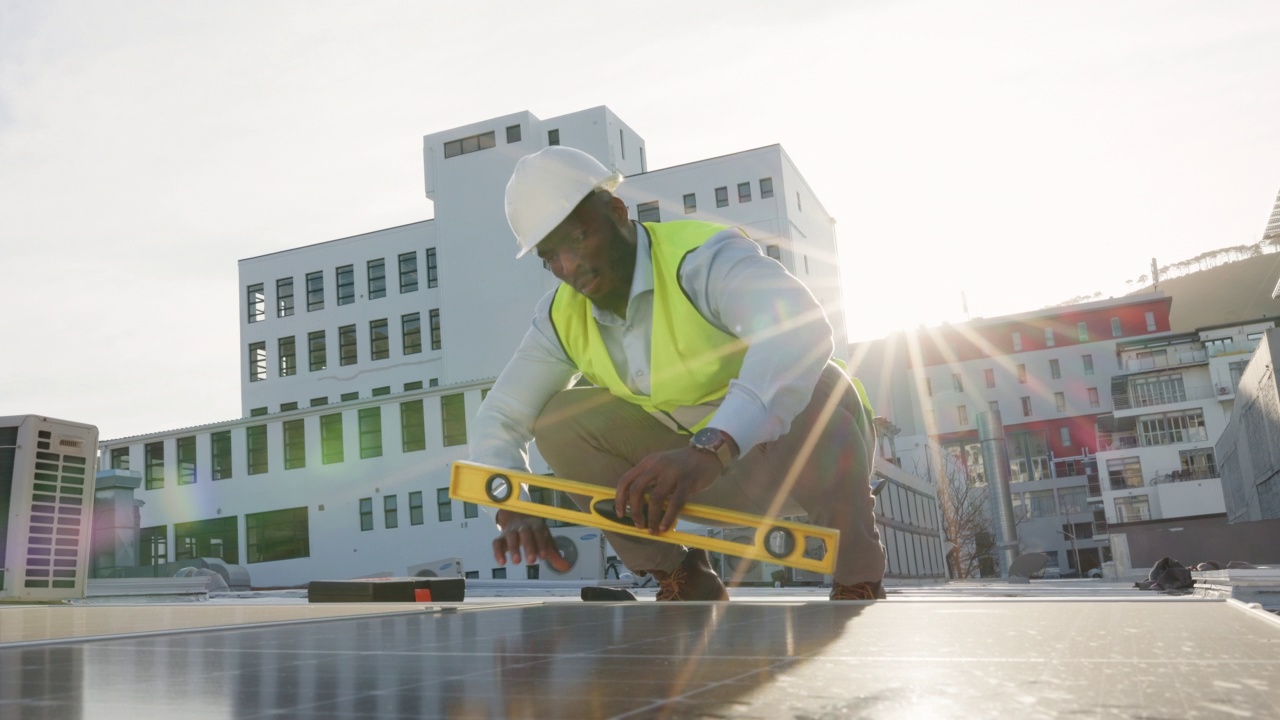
[0,0,1280,438]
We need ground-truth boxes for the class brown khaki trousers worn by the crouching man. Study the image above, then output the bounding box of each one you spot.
[534,365,884,584]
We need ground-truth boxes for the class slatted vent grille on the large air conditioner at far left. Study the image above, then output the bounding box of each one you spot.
[24,440,91,589]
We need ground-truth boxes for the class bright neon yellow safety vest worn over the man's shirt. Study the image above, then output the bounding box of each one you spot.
[552,220,748,432]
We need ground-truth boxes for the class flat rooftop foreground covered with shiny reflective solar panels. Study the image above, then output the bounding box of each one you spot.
[0,580,1280,720]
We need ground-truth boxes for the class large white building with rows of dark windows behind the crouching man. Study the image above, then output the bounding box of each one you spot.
[100,106,847,587]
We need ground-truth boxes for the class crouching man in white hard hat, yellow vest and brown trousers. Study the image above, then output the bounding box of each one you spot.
[471,146,884,600]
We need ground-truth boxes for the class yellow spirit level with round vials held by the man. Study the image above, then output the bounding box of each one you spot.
[449,461,840,574]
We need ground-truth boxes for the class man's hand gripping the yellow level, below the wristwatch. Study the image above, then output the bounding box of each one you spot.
[613,447,722,534]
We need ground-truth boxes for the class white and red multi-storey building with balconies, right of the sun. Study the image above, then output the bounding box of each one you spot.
[852,293,1274,571]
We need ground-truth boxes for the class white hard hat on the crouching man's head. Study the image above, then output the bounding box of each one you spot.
[507,145,622,258]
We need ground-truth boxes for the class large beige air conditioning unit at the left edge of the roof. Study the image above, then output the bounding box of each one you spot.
[0,415,97,602]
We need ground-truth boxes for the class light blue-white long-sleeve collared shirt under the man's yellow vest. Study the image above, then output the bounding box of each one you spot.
[470,223,835,471]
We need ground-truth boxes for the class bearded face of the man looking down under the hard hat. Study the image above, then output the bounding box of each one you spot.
[536,195,636,315]
